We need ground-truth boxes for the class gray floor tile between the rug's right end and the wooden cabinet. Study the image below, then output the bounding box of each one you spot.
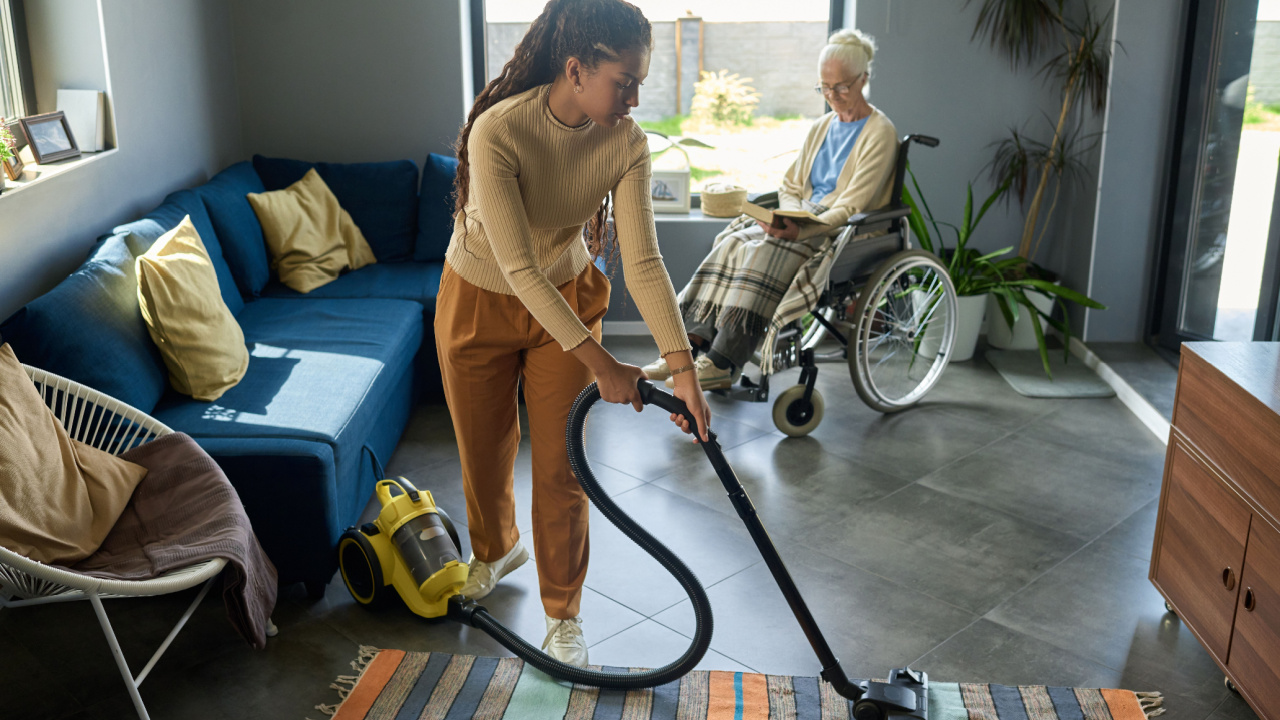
[986,538,1228,706]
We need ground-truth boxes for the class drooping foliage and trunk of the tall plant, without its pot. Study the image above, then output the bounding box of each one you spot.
[965,0,1111,261]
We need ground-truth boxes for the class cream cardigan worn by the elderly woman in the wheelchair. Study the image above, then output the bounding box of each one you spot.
[778,108,897,240]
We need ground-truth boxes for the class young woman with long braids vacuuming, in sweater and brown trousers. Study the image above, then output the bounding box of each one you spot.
[435,0,710,666]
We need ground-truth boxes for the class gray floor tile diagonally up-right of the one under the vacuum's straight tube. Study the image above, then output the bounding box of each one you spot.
[797,484,1084,615]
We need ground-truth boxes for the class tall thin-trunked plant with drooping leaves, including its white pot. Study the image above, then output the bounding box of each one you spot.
[965,0,1111,348]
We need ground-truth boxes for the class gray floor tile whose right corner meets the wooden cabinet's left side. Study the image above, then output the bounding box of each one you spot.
[920,432,1161,541]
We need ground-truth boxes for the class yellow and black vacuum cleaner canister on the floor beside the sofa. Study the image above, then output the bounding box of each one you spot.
[338,478,467,618]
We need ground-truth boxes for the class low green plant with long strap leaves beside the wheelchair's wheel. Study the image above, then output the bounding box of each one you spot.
[902,167,1106,379]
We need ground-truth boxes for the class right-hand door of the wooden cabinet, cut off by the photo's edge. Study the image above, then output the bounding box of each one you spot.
[1226,518,1280,717]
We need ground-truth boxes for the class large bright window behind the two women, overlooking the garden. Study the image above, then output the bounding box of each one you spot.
[477,0,845,192]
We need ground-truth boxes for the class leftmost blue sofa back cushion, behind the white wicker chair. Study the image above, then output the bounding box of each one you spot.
[0,236,168,413]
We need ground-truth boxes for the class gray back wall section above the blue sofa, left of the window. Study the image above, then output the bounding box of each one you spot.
[232,0,471,167]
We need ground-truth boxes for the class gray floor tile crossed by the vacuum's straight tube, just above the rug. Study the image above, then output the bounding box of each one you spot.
[654,542,975,678]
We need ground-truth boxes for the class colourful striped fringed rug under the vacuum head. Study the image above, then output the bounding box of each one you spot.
[316,647,1164,720]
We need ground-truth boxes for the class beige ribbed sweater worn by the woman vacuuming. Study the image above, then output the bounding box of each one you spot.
[445,85,689,355]
